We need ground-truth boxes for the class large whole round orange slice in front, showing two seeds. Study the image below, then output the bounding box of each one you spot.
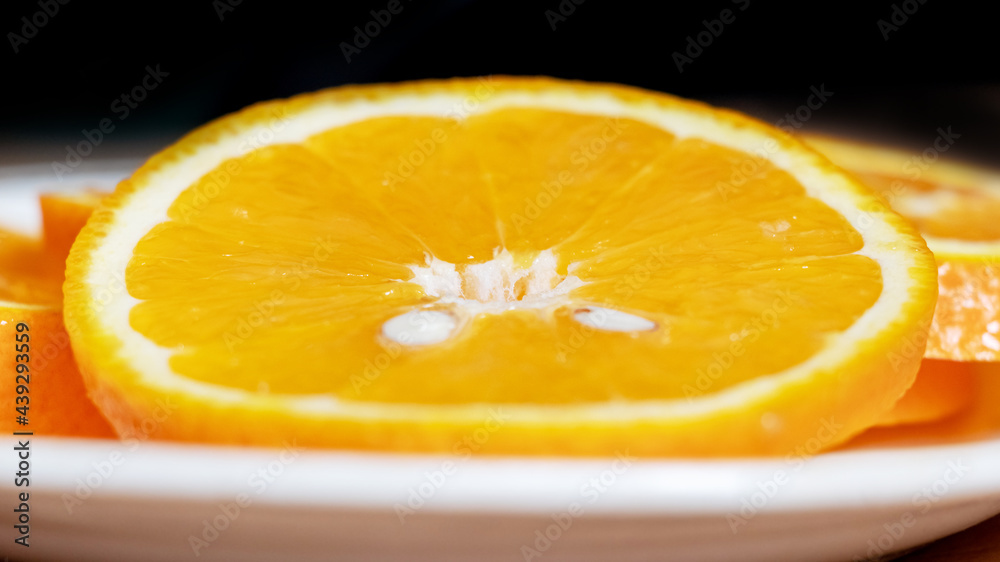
[65,78,937,456]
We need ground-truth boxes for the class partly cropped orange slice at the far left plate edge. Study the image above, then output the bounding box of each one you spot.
[0,225,115,437]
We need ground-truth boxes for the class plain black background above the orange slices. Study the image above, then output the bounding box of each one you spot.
[0,0,1000,165]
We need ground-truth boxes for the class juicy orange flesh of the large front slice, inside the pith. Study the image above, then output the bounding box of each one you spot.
[126,109,881,404]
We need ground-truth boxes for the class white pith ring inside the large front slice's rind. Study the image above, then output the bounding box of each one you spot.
[78,88,917,422]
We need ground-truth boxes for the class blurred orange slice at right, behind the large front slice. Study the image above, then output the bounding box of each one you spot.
[806,132,1000,361]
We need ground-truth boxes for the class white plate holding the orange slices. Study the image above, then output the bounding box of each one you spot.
[0,163,1000,561]
